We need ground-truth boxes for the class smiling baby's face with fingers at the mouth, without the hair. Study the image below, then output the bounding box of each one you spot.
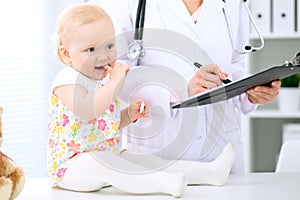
[67,18,116,80]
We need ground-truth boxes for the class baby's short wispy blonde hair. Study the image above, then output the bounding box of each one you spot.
[56,3,111,64]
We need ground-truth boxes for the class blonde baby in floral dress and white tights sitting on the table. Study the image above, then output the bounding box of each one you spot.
[47,3,235,197]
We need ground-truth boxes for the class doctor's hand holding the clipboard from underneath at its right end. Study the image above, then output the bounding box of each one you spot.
[247,81,281,104]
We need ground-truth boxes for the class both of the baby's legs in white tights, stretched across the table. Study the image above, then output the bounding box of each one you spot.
[58,145,235,196]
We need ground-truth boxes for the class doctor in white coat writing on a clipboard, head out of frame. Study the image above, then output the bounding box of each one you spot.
[100,0,280,172]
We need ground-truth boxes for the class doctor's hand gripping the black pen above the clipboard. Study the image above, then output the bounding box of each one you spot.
[188,64,228,96]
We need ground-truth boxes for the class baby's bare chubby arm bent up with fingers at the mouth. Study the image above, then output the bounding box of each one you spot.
[53,63,129,120]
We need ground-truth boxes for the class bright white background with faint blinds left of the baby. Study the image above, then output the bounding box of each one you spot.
[0,0,83,176]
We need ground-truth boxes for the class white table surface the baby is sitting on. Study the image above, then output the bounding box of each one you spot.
[16,173,300,200]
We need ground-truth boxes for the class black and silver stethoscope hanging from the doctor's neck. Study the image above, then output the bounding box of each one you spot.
[127,0,264,60]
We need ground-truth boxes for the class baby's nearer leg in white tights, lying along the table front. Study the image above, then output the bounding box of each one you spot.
[58,152,186,197]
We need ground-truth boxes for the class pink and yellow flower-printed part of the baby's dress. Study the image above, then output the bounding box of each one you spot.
[47,66,121,182]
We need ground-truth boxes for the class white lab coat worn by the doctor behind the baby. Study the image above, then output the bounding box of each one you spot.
[98,0,256,172]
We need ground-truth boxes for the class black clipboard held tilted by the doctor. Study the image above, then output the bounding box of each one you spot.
[171,63,300,109]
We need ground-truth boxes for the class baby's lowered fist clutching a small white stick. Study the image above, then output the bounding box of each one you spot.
[128,100,149,122]
